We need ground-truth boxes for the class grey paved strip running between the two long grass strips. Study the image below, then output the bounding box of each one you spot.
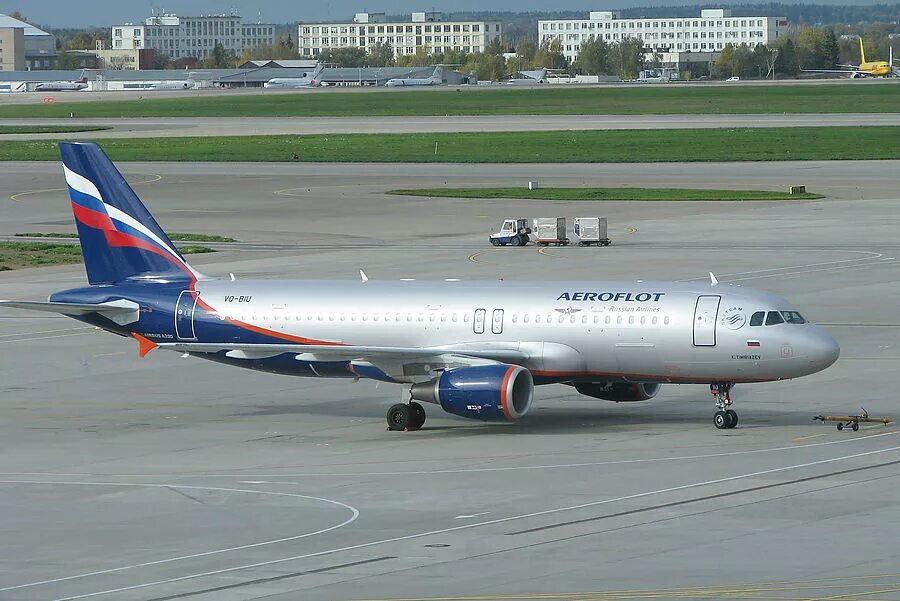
[0,113,900,140]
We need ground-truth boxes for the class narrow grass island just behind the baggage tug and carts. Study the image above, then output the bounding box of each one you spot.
[388,188,822,201]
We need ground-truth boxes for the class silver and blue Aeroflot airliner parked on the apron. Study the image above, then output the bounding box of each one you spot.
[0,143,839,430]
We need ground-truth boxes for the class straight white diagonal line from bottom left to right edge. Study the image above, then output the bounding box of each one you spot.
[37,446,900,601]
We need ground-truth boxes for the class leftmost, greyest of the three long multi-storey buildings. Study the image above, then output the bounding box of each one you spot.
[112,15,275,59]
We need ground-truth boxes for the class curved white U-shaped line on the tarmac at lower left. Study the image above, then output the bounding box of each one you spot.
[0,480,359,592]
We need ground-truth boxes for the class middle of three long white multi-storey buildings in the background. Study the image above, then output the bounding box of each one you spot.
[297,12,502,57]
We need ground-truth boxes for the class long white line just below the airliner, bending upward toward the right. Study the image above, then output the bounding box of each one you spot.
[8,430,900,484]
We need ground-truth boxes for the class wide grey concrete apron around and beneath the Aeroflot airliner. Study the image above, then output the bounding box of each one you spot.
[0,161,900,601]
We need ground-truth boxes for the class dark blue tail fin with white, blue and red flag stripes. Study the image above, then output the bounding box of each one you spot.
[59,142,200,285]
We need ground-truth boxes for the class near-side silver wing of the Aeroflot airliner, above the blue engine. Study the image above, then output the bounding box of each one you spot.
[156,342,529,382]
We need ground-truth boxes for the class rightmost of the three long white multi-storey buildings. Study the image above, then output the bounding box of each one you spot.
[538,8,788,64]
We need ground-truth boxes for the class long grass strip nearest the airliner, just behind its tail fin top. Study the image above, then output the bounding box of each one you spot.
[0,127,900,163]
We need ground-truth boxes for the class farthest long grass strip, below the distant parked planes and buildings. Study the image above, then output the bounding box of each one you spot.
[0,82,900,118]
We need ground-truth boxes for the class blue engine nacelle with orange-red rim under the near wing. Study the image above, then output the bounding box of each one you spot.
[410,364,534,421]
